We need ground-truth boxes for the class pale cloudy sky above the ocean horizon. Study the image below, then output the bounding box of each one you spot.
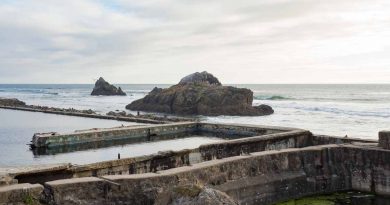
[0,0,390,84]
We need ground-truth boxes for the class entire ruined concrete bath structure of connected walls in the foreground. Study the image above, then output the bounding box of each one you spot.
[0,122,390,204]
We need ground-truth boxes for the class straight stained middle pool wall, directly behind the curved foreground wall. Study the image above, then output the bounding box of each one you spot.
[71,130,311,177]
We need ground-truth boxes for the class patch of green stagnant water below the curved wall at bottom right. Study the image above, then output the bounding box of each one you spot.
[276,192,390,205]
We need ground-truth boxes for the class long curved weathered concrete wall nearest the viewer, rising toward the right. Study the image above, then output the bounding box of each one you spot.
[41,145,390,204]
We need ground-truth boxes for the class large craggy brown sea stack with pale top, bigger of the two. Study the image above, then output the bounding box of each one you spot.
[126,71,274,116]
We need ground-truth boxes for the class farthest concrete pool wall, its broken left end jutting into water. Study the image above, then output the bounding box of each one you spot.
[32,122,297,148]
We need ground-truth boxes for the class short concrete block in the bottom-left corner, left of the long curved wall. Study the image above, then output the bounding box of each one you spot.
[0,184,43,204]
